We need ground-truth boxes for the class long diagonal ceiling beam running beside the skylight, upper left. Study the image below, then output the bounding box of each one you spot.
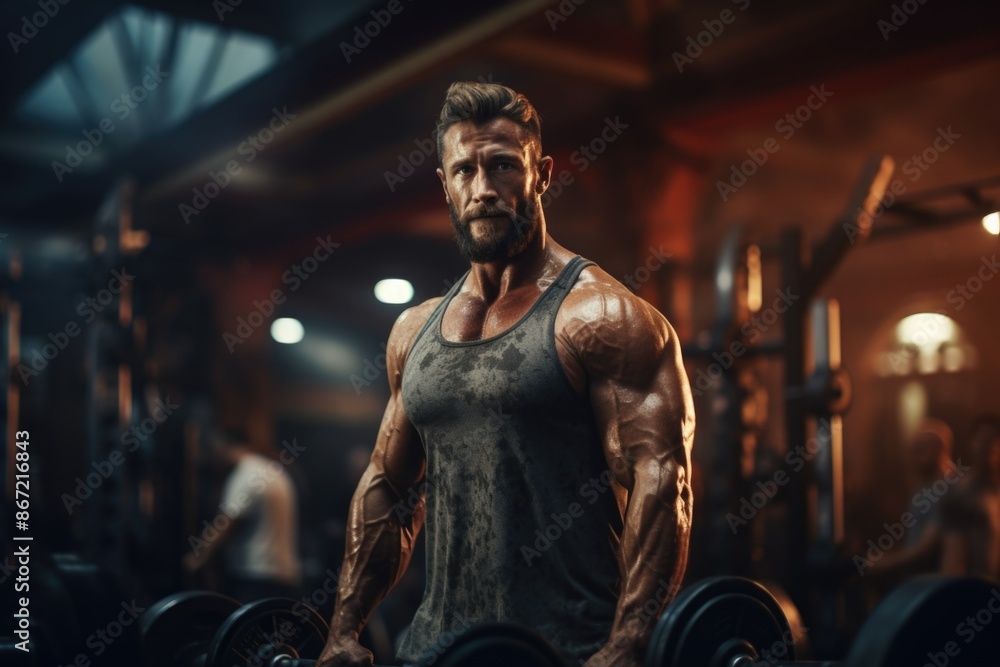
[138,0,552,197]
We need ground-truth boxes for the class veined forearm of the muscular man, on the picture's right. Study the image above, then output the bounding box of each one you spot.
[609,471,692,661]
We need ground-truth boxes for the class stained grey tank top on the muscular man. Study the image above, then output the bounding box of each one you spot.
[399,257,622,664]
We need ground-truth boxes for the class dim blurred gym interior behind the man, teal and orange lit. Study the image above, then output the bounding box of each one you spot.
[0,0,1000,665]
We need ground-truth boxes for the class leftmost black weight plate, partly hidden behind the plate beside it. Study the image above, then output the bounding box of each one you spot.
[139,591,240,667]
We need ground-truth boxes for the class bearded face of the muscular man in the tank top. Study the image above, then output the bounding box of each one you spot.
[437,118,552,262]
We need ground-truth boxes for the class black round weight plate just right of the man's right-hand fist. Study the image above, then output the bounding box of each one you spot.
[646,577,795,667]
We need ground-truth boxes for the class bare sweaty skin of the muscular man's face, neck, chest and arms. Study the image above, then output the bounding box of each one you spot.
[319,118,694,667]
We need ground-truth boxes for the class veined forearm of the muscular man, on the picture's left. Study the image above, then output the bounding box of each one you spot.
[330,476,424,637]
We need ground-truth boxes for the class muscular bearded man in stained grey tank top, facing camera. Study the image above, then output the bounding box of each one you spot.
[320,83,694,667]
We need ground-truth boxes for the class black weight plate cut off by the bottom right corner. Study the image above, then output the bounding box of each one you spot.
[845,576,1000,667]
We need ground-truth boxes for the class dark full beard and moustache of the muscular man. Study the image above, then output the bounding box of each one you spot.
[448,202,539,262]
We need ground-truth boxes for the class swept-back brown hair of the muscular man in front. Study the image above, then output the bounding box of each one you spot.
[436,81,542,164]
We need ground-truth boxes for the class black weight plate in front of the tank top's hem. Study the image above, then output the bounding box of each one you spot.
[428,623,566,667]
